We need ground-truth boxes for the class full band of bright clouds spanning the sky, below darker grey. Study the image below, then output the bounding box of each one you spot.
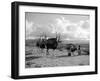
[26,16,90,40]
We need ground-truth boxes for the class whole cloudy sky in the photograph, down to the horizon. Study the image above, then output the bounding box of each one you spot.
[25,12,90,40]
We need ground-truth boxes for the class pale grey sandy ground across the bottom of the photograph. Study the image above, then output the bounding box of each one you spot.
[25,49,89,68]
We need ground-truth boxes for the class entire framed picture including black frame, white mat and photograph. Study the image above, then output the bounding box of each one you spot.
[11,2,97,79]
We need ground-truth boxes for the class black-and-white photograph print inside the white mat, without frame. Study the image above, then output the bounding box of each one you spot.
[25,12,90,68]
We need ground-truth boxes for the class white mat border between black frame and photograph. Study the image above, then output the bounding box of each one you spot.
[19,5,95,76]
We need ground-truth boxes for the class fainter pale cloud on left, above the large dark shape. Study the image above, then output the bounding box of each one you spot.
[26,20,54,39]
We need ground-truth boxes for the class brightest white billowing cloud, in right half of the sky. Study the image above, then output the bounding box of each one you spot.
[50,17,89,40]
